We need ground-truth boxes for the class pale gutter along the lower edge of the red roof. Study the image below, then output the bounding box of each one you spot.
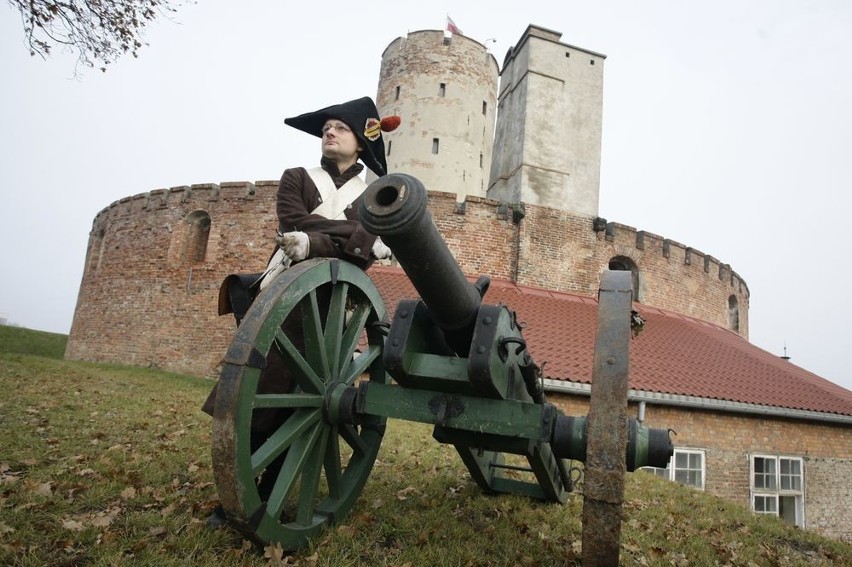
[544,378,852,425]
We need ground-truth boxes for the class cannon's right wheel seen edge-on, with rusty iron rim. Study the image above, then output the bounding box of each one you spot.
[583,271,633,567]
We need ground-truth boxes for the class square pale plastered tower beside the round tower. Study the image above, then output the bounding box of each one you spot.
[488,25,606,217]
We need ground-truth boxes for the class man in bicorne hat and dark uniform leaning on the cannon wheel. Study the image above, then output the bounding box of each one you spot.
[202,97,399,525]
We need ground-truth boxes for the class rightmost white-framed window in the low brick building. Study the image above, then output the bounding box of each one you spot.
[750,455,805,528]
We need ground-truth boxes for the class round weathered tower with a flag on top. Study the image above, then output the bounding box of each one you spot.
[376,30,498,201]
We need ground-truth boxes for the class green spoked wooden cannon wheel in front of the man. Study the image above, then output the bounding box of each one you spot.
[213,259,388,549]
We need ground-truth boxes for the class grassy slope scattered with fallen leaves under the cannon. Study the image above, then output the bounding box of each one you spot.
[0,326,852,567]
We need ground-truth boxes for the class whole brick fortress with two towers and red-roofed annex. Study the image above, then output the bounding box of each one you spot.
[66,26,852,540]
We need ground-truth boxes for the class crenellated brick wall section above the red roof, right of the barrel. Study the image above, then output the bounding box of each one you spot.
[429,191,750,338]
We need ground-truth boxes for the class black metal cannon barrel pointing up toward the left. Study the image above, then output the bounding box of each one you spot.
[360,173,481,346]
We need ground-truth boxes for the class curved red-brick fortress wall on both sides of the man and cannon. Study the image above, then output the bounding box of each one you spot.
[65,181,749,376]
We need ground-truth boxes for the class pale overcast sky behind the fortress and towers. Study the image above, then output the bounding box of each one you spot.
[0,0,852,389]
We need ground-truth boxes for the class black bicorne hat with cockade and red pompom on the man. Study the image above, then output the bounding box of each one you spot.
[284,96,400,177]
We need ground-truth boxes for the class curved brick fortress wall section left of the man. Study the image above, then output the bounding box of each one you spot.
[65,181,278,376]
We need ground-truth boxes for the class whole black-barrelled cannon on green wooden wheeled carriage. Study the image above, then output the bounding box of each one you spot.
[212,174,673,549]
